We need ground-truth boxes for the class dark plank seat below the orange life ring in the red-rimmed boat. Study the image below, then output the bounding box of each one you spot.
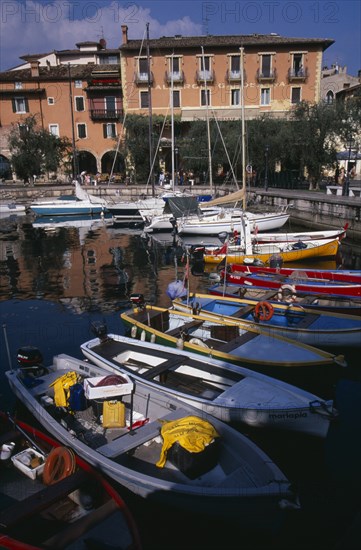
[0,470,89,529]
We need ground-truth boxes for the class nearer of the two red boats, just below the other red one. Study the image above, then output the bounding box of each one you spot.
[222,271,361,297]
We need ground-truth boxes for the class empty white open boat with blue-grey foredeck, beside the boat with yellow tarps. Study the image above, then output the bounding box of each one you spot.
[81,326,336,437]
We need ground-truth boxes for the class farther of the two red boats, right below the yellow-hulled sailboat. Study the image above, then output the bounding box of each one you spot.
[230,264,361,285]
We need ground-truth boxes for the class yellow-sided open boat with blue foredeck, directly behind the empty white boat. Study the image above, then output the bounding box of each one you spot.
[117,305,345,378]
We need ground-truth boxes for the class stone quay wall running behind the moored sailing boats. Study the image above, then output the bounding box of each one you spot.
[0,183,361,241]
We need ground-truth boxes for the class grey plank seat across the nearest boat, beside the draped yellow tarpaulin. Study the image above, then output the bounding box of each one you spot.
[97,408,189,458]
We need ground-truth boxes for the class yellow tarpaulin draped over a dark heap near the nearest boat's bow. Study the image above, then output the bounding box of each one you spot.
[157,416,219,468]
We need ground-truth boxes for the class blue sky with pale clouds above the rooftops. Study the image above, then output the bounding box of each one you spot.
[0,0,361,76]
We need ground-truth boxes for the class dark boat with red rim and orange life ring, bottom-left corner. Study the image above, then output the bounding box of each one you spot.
[0,413,142,550]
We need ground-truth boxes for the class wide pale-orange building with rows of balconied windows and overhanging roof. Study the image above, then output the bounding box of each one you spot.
[120,26,333,121]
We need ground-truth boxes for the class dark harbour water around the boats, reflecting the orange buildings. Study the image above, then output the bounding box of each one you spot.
[0,216,361,550]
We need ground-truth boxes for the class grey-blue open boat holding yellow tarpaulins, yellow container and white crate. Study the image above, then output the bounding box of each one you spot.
[6,355,295,527]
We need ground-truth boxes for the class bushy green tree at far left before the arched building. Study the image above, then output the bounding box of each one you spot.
[9,116,71,182]
